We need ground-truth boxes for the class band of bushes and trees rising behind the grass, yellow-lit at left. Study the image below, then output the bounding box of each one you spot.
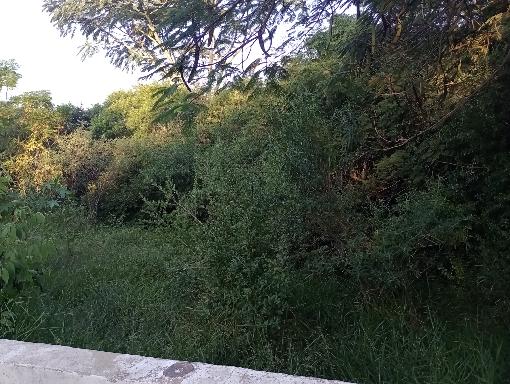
[2,11,509,295]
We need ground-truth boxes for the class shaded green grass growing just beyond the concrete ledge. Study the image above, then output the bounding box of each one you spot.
[5,207,509,384]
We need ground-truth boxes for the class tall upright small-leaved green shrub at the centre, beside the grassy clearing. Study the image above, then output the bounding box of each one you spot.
[177,130,306,328]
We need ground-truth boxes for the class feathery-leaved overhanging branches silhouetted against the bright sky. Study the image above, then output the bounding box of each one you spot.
[44,0,348,89]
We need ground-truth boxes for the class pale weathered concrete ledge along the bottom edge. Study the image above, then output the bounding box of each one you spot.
[0,340,348,384]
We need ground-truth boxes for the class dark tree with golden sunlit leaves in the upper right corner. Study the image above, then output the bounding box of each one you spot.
[350,0,510,153]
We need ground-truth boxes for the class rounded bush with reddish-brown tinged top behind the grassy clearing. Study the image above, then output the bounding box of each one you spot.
[56,131,193,219]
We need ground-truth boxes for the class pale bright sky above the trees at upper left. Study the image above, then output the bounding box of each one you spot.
[0,0,140,107]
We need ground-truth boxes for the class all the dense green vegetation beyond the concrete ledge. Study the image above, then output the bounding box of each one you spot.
[0,0,510,383]
